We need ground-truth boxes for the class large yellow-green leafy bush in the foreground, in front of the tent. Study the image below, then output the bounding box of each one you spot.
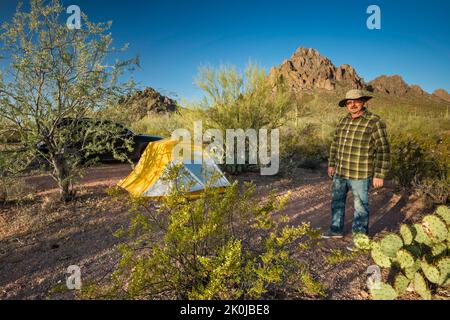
[82,165,321,299]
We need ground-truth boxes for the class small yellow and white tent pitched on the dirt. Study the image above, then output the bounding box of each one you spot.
[118,139,230,198]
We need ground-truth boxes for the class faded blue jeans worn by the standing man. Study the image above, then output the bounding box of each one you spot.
[330,175,372,235]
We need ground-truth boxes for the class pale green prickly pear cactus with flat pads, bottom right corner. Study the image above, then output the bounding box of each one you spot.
[355,206,450,300]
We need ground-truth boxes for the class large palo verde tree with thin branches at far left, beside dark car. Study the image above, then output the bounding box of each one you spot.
[0,0,137,201]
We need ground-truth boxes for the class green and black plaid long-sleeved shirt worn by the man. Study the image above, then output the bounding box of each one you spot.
[328,110,390,180]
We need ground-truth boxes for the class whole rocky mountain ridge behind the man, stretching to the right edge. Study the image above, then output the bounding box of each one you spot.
[269,47,450,115]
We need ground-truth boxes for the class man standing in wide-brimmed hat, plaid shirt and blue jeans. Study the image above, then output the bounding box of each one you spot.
[323,90,390,238]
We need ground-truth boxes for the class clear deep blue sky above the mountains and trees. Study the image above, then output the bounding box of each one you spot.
[0,0,450,100]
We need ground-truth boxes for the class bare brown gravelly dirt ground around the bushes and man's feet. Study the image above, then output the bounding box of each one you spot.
[0,164,428,299]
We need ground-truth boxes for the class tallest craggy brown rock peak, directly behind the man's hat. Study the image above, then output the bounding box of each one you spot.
[269,47,365,92]
